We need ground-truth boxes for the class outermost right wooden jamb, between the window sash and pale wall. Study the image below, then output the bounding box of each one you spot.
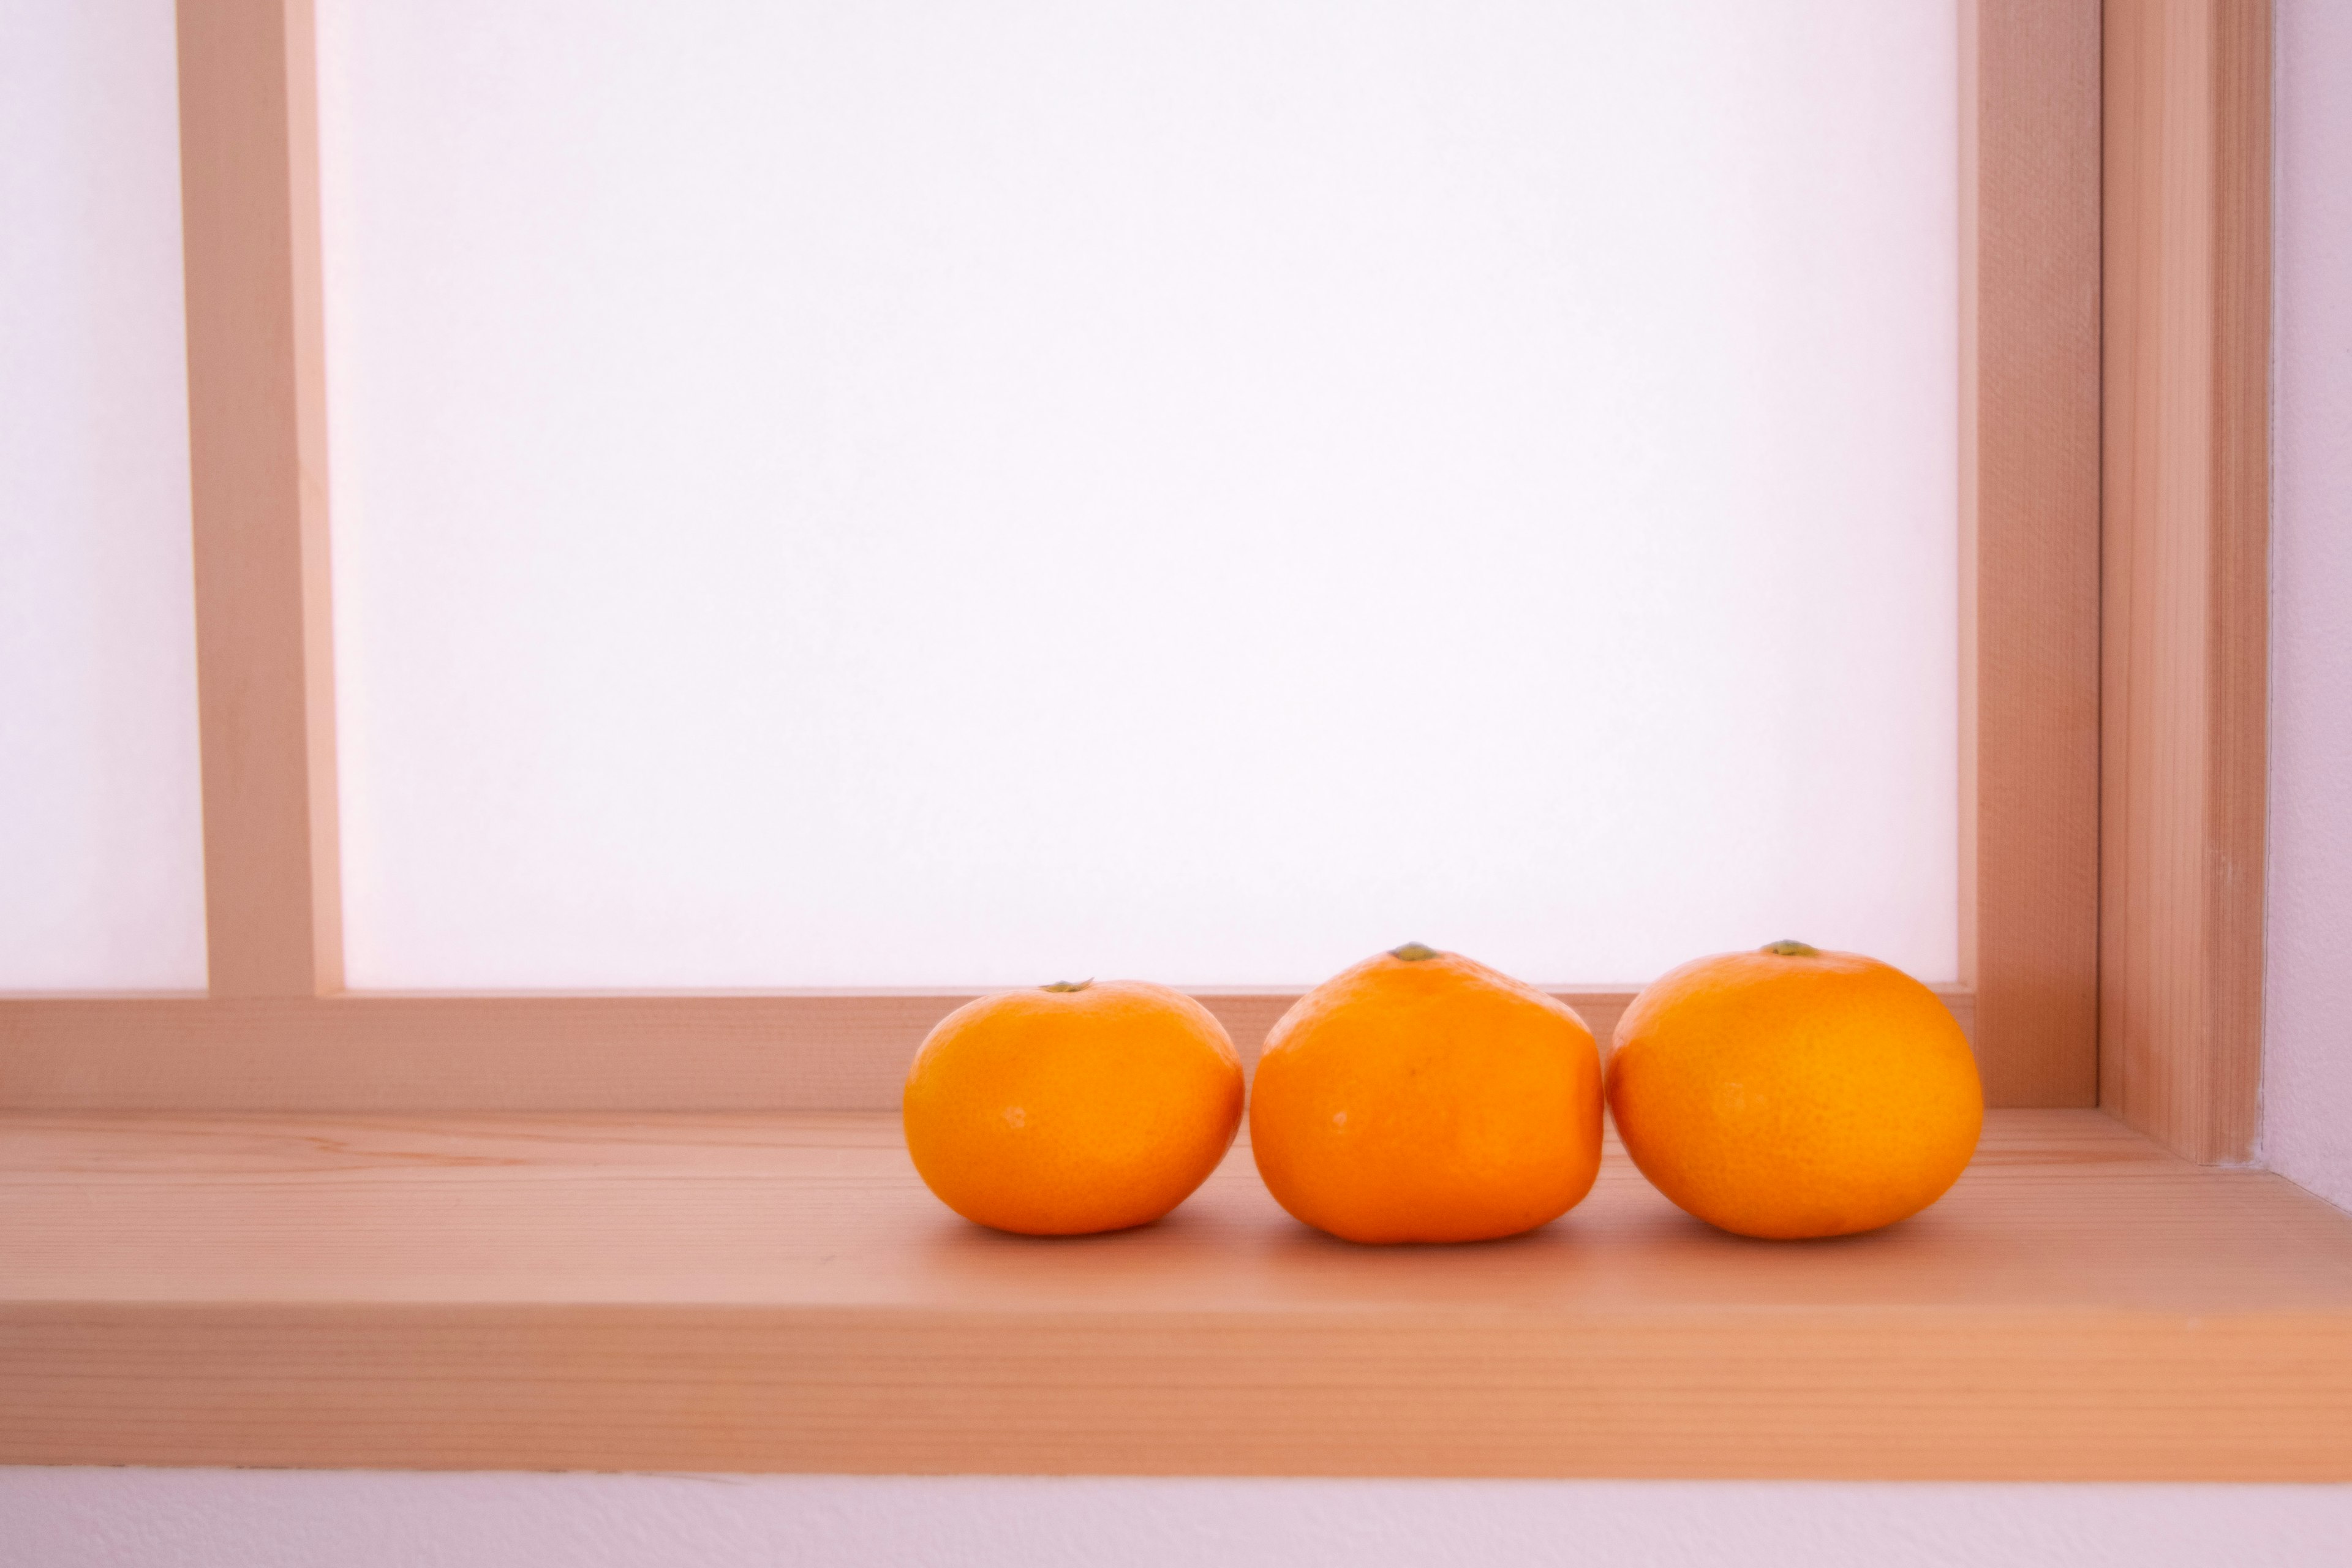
[2100,0,2272,1161]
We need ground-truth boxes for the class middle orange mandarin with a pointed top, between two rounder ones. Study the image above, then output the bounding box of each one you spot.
[1249,943,1602,1242]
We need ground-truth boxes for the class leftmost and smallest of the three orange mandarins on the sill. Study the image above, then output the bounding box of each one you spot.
[901,980,1242,1237]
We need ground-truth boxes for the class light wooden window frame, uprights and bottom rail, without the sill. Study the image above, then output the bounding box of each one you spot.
[0,0,2270,1164]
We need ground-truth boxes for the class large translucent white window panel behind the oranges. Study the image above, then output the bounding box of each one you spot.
[322,0,1957,985]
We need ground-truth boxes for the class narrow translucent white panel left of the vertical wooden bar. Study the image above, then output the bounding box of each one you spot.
[0,0,205,990]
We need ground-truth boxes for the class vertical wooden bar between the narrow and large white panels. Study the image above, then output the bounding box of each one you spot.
[179,0,344,997]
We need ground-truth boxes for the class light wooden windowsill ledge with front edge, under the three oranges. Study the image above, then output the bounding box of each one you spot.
[0,1112,2352,1481]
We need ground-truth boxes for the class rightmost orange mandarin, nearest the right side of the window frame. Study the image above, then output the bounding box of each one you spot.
[1609,943,1985,1239]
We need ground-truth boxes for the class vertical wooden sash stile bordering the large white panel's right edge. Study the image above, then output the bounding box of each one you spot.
[1959,0,2100,1105]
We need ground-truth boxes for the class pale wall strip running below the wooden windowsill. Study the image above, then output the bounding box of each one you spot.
[0,1469,2352,1568]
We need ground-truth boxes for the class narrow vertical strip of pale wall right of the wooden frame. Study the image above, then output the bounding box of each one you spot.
[2263,0,2352,1208]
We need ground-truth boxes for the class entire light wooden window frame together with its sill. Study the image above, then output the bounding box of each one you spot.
[13,0,2352,1481]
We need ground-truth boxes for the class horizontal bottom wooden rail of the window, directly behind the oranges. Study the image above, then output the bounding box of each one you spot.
[0,990,1973,1112]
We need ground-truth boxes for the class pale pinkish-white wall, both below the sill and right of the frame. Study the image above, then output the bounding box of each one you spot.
[0,0,2352,1568]
